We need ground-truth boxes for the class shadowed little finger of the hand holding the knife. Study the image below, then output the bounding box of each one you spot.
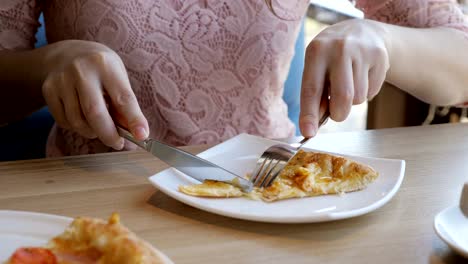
[42,77,70,129]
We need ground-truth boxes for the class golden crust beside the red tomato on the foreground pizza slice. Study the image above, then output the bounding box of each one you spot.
[47,214,172,264]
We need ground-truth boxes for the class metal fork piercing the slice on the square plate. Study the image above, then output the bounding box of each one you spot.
[250,111,330,187]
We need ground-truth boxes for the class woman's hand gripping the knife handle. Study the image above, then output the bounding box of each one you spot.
[42,40,149,150]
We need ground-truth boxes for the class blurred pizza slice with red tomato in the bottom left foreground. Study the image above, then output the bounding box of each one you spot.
[6,214,172,264]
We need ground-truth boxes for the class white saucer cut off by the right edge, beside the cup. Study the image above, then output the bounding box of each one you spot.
[434,206,468,258]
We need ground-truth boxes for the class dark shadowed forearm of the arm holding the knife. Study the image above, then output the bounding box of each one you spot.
[0,47,45,124]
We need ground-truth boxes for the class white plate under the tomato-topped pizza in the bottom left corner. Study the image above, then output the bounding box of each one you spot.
[0,210,72,263]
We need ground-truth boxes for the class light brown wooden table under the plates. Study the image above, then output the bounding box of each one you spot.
[0,125,468,264]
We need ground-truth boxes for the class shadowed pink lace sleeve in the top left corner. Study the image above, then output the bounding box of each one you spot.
[0,0,41,50]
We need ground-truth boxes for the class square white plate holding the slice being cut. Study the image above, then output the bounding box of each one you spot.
[149,134,405,223]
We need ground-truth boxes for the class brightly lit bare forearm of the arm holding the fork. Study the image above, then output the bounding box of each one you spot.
[382,24,468,106]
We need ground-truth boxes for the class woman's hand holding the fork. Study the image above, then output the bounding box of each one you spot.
[299,20,389,137]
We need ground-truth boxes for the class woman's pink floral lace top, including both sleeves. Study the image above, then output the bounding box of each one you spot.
[0,0,468,156]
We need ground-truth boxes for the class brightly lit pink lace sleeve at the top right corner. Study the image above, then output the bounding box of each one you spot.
[356,0,468,36]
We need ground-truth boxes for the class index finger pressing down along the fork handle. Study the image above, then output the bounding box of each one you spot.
[299,42,327,137]
